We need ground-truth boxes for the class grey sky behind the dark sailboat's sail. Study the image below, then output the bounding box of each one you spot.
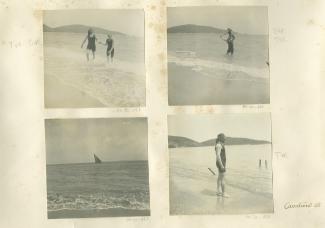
[45,118,148,164]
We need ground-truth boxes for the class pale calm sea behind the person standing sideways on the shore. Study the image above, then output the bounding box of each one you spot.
[169,144,273,199]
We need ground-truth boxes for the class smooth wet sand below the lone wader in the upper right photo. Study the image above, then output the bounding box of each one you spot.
[168,63,270,105]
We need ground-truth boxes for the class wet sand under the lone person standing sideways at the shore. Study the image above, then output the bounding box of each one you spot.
[170,176,273,215]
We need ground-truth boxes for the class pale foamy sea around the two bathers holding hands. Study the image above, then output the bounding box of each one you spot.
[43,32,146,107]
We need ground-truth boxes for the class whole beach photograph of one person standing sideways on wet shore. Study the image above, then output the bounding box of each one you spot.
[168,113,274,215]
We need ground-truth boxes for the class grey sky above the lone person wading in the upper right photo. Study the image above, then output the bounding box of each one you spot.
[167,6,268,35]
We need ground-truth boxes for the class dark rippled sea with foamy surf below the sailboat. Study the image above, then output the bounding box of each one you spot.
[47,161,150,216]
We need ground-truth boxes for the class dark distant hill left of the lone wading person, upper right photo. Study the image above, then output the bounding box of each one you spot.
[167,24,225,33]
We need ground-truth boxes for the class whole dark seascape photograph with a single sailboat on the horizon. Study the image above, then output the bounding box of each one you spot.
[45,118,150,219]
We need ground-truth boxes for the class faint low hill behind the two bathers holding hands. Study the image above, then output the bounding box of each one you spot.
[43,24,125,35]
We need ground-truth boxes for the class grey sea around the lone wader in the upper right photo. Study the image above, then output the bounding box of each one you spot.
[168,33,269,78]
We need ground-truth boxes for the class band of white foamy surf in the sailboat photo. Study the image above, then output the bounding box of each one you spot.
[47,192,149,211]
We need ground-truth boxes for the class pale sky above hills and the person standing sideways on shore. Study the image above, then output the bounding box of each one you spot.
[168,113,271,142]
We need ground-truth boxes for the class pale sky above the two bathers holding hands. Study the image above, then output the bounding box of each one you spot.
[43,9,144,37]
